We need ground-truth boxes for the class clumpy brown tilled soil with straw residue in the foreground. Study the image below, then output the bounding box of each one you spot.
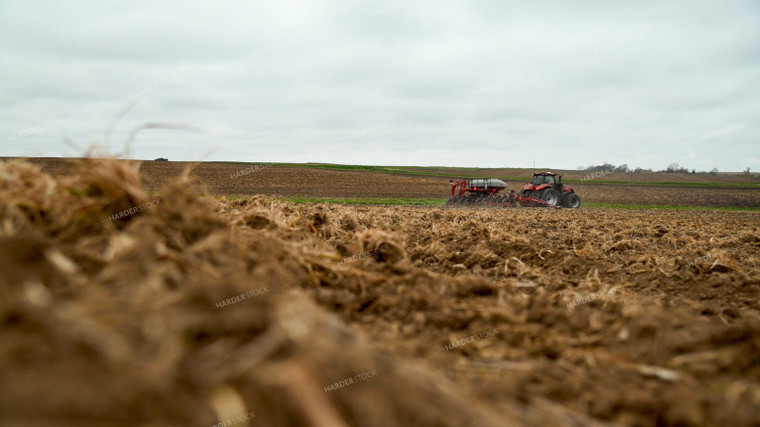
[0,160,760,426]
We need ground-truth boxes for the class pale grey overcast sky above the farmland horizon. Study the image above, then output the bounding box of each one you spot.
[0,0,760,171]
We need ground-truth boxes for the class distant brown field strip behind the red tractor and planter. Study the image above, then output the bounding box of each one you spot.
[16,159,760,208]
